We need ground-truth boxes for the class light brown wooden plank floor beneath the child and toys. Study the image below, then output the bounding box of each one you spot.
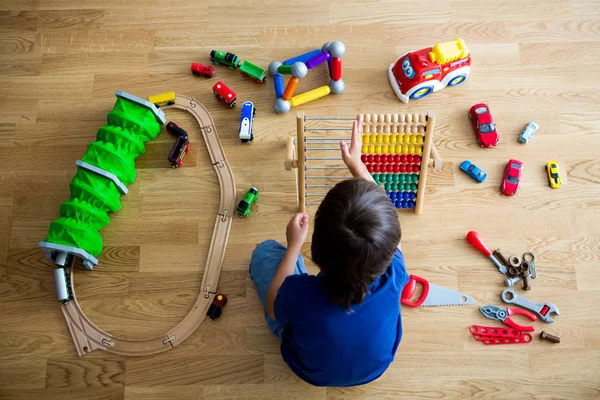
[0,0,600,400]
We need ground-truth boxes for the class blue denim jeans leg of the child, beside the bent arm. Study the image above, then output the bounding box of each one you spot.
[250,240,307,339]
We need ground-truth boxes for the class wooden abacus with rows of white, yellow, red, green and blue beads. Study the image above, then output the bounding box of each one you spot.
[284,112,442,214]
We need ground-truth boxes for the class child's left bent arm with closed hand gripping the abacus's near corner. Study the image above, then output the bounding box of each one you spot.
[267,213,308,319]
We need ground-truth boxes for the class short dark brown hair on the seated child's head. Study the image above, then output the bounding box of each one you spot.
[311,179,401,311]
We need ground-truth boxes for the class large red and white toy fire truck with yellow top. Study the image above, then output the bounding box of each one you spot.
[388,39,471,103]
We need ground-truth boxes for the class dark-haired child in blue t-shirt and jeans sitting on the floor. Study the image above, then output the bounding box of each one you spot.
[250,117,408,386]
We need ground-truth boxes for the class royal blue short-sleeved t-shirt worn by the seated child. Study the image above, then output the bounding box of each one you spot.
[274,250,408,386]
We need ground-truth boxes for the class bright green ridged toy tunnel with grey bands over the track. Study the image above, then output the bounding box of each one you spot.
[40,90,165,269]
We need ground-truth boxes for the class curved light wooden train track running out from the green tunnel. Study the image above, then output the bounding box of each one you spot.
[62,95,235,356]
